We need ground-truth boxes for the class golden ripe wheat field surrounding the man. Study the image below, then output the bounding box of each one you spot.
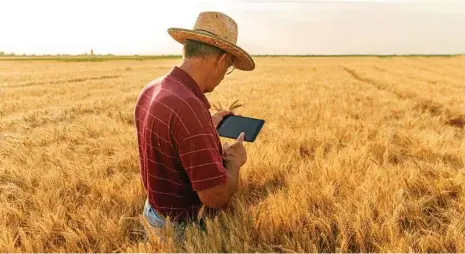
[0,56,465,252]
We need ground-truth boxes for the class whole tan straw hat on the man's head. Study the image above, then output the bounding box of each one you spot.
[168,12,255,71]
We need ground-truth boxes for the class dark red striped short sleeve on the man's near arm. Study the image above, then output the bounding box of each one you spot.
[178,130,228,191]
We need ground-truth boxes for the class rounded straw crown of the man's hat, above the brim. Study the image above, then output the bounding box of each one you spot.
[194,12,238,44]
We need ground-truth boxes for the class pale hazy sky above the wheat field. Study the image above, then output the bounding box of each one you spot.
[0,0,465,55]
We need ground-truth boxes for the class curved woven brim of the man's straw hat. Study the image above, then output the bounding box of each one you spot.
[168,28,255,71]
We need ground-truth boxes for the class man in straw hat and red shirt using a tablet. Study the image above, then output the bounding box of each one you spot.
[135,12,255,230]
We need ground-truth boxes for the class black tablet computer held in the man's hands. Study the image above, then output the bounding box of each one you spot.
[217,115,265,142]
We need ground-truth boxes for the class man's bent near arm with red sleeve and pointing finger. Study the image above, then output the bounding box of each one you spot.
[175,117,246,208]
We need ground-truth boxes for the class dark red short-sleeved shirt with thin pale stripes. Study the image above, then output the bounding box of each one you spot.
[134,67,227,220]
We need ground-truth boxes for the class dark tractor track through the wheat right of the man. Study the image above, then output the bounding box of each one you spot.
[341,66,465,129]
